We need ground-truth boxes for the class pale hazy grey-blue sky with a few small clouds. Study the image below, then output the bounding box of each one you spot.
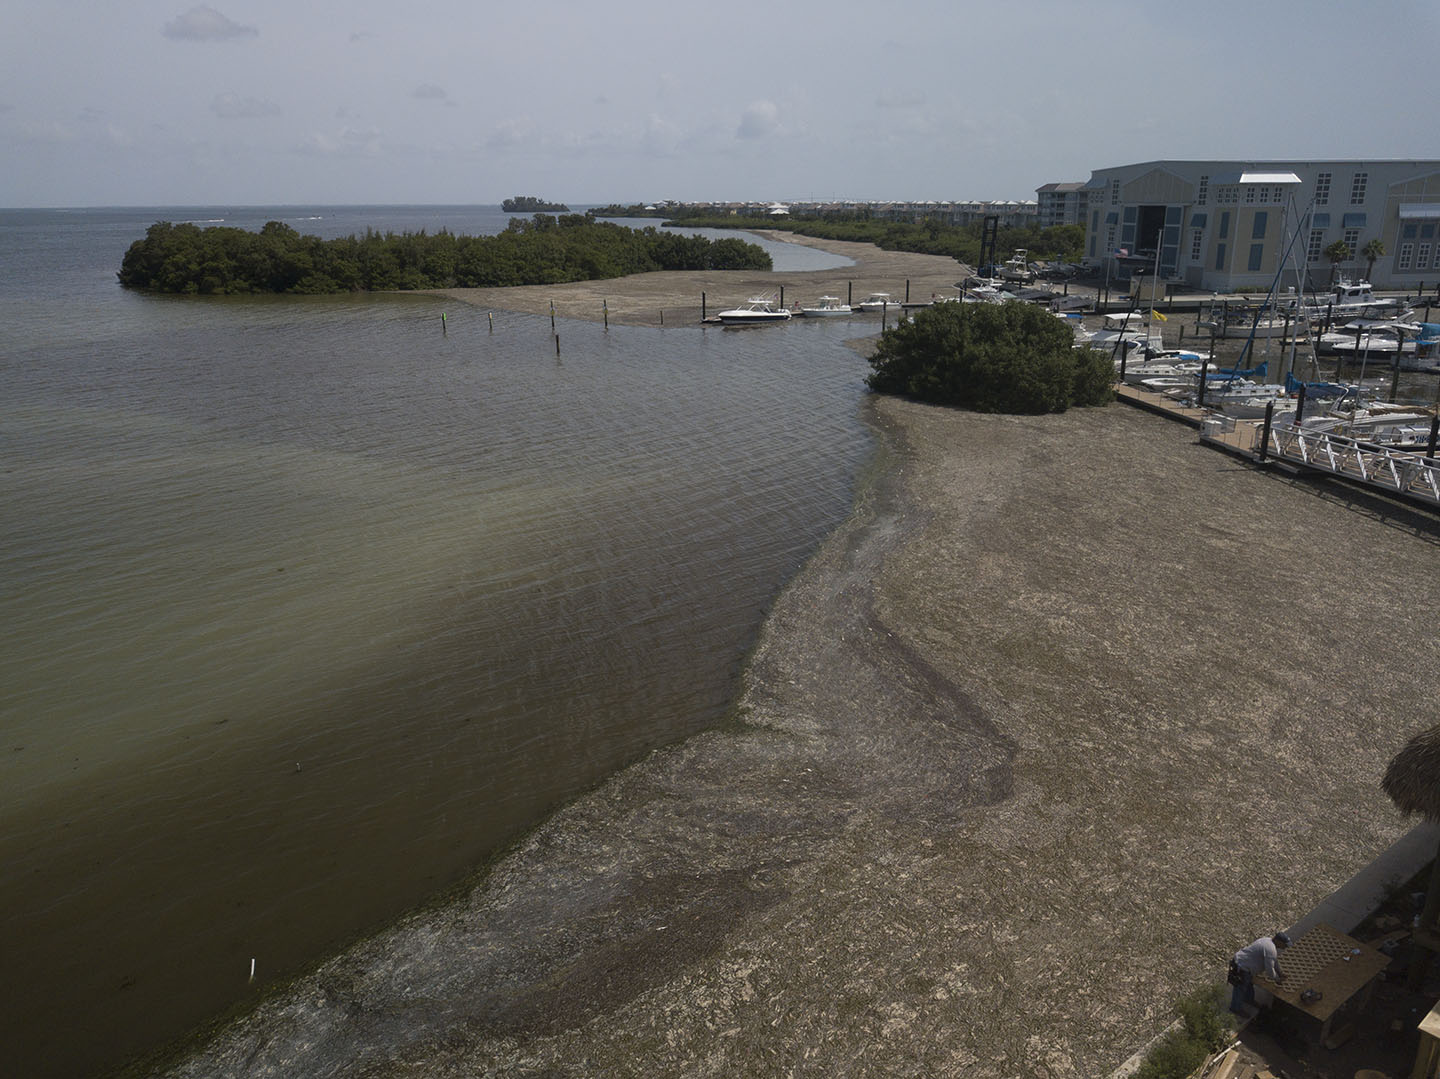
[0,0,1440,207]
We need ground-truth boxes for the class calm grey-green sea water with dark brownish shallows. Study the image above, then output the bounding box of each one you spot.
[0,207,870,1076]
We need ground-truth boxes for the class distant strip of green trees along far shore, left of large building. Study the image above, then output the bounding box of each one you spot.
[593,206,1084,267]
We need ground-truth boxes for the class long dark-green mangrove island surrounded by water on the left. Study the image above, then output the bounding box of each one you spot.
[120,213,772,295]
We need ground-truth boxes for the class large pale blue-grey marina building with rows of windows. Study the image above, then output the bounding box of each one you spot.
[1084,161,1440,292]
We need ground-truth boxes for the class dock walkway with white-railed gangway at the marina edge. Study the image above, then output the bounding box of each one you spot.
[1115,385,1440,509]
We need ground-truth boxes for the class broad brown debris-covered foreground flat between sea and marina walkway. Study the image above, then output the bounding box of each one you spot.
[157,246,1440,1079]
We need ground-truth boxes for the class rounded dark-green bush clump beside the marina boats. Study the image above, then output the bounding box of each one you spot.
[867,301,1115,413]
